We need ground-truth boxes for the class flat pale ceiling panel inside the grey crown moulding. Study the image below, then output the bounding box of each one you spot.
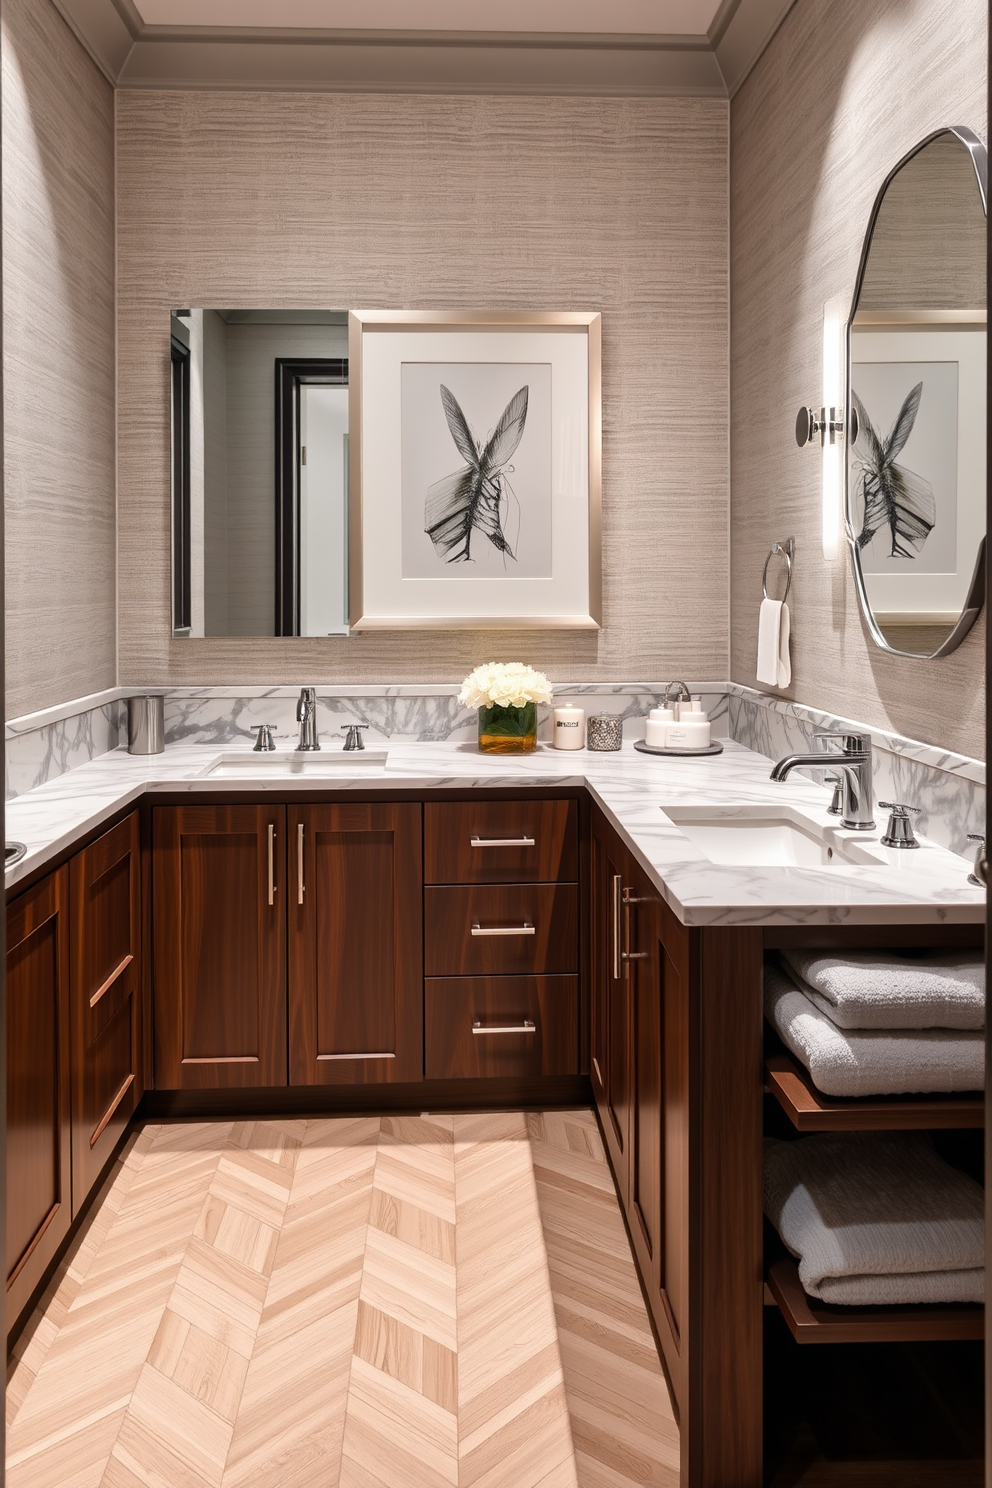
[134,0,721,36]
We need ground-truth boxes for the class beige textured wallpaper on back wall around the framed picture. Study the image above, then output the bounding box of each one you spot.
[117,92,729,683]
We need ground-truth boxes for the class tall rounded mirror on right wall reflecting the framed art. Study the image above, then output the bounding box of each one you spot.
[846,128,988,658]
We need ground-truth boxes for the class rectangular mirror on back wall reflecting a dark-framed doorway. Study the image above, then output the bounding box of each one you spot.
[171,308,348,638]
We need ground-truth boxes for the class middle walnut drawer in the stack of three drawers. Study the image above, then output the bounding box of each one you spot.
[424,884,579,976]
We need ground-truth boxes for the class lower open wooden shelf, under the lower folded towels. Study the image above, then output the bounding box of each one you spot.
[767,1256,985,1344]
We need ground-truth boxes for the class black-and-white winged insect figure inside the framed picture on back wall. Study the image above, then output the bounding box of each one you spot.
[424,382,529,564]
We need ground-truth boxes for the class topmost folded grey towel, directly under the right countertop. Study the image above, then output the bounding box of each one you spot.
[782,951,985,1028]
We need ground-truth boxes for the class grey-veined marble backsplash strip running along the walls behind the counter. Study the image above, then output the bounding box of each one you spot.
[6,679,985,856]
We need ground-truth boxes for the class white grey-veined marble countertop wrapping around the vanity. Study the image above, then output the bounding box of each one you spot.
[6,740,985,926]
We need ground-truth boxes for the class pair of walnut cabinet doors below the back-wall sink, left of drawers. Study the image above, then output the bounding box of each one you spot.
[153,802,424,1089]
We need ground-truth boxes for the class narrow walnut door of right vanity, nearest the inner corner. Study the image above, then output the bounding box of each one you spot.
[590,820,631,1204]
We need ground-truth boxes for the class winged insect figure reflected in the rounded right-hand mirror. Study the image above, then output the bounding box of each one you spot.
[851,382,937,558]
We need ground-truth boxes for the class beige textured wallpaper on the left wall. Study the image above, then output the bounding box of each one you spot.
[3,0,116,717]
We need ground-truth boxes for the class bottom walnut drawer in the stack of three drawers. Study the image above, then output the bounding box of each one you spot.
[424,976,579,1080]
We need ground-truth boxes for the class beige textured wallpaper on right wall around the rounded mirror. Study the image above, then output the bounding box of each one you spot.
[730,0,988,757]
